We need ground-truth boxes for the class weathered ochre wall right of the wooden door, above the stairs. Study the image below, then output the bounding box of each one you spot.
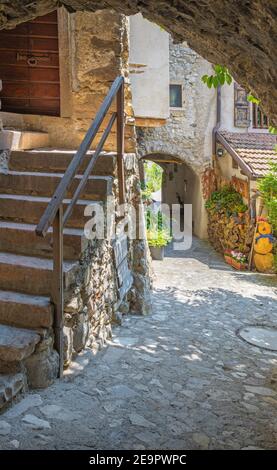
[2,9,135,152]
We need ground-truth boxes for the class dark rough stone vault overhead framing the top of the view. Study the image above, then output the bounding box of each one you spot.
[0,0,277,124]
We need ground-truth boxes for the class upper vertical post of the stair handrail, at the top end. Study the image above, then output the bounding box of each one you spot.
[116,82,125,204]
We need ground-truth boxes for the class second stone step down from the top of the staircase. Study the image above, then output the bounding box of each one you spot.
[0,171,113,201]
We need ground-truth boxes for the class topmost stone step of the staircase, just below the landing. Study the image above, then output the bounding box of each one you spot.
[9,149,116,176]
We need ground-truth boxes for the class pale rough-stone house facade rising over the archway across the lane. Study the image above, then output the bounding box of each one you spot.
[137,40,216,238]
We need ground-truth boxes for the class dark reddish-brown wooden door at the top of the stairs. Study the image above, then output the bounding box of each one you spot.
[0,11,60,116]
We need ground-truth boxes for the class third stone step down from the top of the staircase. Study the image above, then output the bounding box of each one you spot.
[0,194,99,229]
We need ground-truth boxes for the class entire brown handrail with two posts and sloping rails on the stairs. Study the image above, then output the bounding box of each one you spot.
[36,77,125,377]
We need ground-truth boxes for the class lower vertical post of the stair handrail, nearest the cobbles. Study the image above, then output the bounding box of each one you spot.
[52,204,64,377]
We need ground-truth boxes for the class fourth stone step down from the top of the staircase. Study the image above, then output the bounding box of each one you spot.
[0,221,88,260]
